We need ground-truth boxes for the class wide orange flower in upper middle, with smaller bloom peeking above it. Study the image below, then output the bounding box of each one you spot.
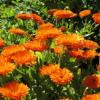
[36,28,62,40]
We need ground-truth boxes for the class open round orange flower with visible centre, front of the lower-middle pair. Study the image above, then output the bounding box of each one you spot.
[50,68,73,85]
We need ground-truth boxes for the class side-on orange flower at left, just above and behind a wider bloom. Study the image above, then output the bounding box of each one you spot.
[1,45,25,56]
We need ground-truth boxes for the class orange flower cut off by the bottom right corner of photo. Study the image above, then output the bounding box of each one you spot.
[82,93,100,100]
